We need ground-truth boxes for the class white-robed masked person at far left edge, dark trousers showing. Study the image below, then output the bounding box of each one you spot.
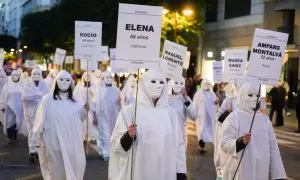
[0,70,27,144]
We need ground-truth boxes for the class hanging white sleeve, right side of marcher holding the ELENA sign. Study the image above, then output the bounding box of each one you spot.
[170,108,187,174]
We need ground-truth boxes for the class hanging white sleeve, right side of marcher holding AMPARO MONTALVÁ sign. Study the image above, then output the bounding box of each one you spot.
[268,120,287,179]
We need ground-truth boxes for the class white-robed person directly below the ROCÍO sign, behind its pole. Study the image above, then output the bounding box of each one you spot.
[74,72,96,141]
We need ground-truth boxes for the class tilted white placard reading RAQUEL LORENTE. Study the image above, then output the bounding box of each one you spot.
[161,40,187,79]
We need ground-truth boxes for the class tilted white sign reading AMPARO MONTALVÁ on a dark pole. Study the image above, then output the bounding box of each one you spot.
[247,28,288,85]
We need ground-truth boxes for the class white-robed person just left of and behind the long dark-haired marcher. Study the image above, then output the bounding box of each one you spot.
[22,67,49,162]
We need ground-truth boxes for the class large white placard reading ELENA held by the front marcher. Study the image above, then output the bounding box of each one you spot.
[116,3,162,69]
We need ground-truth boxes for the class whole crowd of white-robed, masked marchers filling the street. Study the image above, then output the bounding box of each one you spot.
[0,67,287,180]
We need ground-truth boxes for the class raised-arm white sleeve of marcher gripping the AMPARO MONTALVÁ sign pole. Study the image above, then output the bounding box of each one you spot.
[221,112,241,157]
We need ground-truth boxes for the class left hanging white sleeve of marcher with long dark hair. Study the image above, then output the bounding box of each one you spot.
[31,96,49,147]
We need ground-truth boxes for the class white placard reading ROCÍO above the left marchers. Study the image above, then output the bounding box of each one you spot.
[74,21,102,61]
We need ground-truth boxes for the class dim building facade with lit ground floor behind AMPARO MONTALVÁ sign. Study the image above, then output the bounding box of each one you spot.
[197,0,300,95]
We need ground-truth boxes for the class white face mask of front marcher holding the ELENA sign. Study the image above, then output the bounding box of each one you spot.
[145,79,164,99]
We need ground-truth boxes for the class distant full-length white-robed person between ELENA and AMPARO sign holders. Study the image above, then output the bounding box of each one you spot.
[193,79,218,154]
